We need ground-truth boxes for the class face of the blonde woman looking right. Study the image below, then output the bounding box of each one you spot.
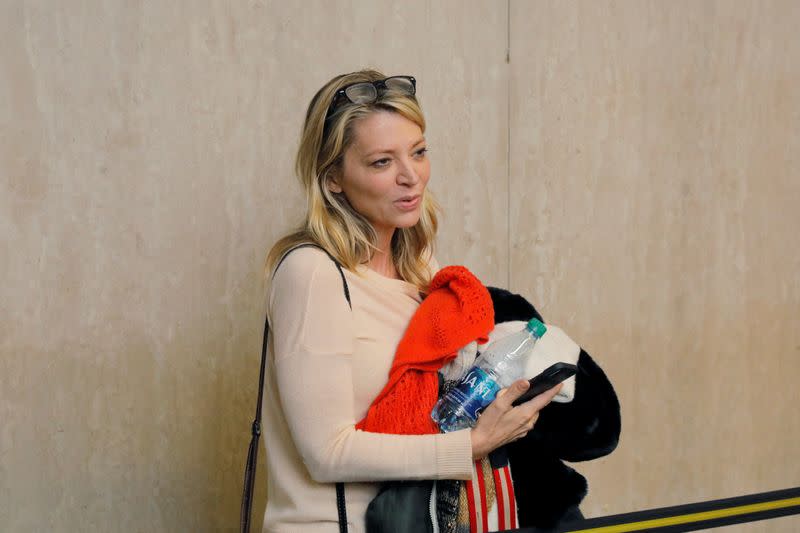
[328,111,431,246]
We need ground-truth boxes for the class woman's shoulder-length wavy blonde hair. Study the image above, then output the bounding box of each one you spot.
[266,69,439,292]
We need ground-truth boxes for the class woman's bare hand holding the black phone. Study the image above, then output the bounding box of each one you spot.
[470,379,561,459]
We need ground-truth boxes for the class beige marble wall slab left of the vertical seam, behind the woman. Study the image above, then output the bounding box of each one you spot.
[0,1,508,531]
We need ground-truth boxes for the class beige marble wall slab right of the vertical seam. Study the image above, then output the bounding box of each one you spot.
[509,1,800,531]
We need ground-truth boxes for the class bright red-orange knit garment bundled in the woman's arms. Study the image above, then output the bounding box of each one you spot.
[356,266,494,435]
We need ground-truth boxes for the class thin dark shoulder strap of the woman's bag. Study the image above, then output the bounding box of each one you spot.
[239,243,353,533]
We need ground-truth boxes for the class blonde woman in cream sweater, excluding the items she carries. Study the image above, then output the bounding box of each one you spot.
[263,70,557,532]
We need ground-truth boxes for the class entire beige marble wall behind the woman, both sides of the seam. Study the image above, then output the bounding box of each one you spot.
[0,0,800,532]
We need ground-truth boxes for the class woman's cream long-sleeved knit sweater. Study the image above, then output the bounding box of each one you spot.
[263,248,472,533]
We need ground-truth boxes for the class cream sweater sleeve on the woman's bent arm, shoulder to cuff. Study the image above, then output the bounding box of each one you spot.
[270,248,472,482]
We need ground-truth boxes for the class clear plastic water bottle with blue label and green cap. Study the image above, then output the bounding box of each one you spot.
[431,318,547,433]
